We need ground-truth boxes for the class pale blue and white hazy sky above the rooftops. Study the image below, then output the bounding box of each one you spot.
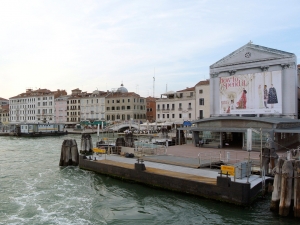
[0,0,300,99]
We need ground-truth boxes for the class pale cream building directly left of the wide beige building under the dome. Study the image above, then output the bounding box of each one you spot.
[80,90,107,122]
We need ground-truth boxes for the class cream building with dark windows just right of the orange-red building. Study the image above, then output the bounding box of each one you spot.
[156,87,196,124]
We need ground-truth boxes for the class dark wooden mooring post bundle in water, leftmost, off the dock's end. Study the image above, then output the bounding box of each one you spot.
[59,139,79,166]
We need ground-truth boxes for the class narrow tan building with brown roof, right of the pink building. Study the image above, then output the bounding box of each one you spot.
[66,88,90,126]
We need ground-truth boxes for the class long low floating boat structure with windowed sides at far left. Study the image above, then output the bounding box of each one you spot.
[10,123,68,137]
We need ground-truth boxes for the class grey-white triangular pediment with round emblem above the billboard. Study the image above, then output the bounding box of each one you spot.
[210,42,295,68]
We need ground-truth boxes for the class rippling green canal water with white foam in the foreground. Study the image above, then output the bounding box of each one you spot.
[0,134,299,225]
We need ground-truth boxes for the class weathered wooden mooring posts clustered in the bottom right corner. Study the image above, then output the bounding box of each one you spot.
[270,158,300,217]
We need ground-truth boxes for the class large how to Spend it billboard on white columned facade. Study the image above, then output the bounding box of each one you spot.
[220,71,282,114]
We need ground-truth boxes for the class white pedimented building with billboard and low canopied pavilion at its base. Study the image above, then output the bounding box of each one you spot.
[191,42,300,150]
